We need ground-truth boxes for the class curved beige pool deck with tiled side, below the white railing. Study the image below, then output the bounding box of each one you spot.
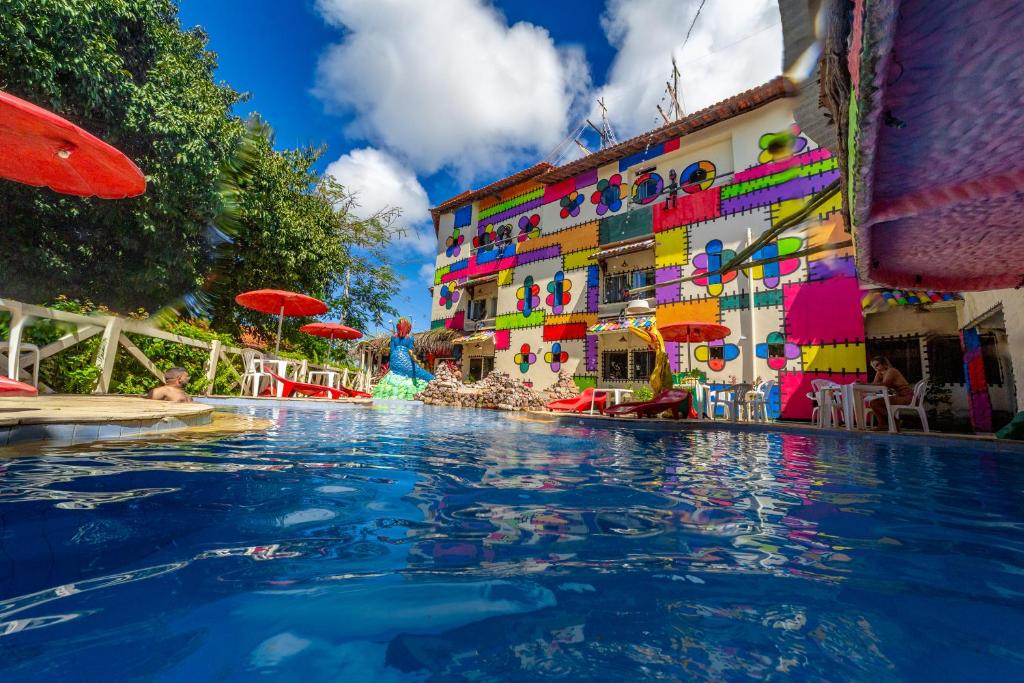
[0,394,214,447]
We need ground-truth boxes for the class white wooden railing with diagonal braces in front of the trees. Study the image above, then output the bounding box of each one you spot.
[0,298,362,395]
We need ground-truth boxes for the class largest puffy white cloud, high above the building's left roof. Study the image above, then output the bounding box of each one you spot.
[316,0,590,180]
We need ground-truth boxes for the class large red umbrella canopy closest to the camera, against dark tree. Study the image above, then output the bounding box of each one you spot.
[0,91,145,200]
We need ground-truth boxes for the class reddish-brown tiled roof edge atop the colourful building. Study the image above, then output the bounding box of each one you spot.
[430,76,798,232]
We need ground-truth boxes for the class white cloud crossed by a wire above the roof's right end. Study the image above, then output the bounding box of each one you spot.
[600,0,782,138]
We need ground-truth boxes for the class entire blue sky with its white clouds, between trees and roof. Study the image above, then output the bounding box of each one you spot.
[180,0,781,329]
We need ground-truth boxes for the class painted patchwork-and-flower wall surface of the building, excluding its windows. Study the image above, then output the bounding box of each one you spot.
[432,101,866,419]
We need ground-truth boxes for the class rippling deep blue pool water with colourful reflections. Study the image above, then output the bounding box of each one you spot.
[0,405,1024,683]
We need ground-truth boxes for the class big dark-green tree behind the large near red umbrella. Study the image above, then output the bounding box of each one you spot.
[0,0,243,311]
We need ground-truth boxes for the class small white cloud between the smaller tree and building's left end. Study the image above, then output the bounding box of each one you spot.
[327,147,436,255]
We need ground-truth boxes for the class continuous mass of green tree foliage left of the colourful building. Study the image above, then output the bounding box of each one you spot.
[0,0,397,350]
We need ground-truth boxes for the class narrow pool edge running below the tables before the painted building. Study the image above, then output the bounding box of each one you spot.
[526,411,1024,455]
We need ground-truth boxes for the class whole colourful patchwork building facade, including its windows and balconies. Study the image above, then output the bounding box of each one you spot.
[423,79,1015,419]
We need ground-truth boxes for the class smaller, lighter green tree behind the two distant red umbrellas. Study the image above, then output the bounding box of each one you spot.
[203,118,398,356]
